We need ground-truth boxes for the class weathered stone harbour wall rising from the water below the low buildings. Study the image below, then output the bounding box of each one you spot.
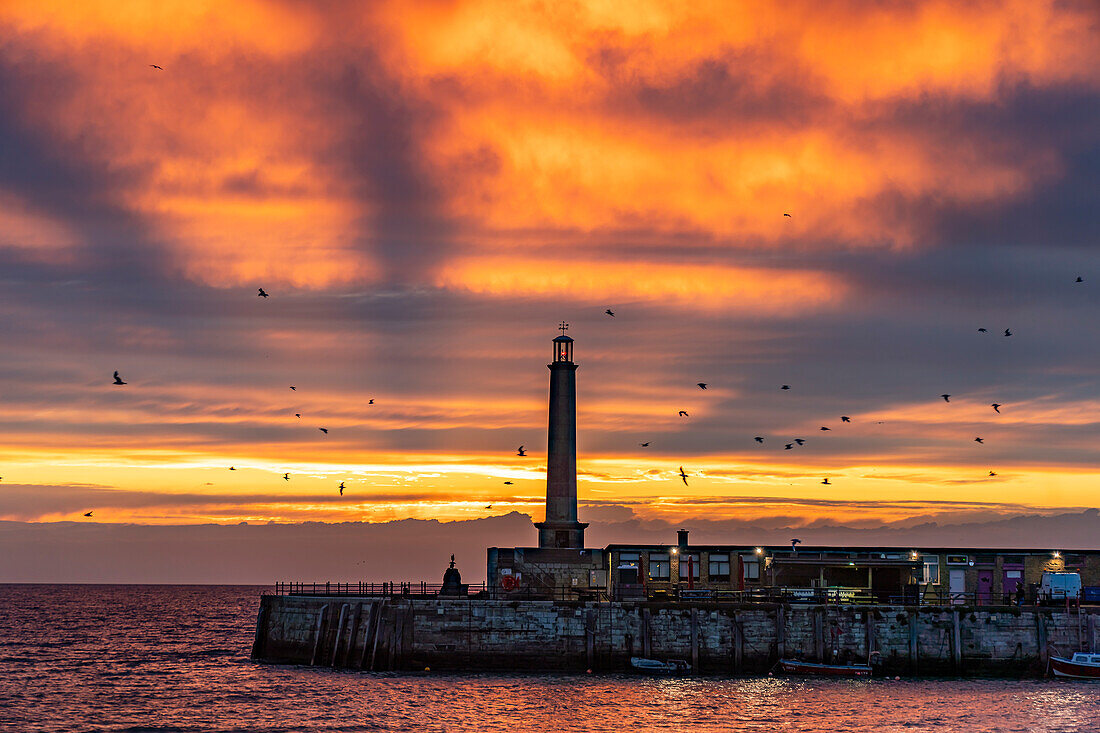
[252,595,1100,677]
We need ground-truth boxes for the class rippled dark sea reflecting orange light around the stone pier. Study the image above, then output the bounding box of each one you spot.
[0,584,1100,733]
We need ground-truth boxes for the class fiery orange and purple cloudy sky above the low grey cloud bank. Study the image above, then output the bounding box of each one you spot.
[0,0,1100,523]
